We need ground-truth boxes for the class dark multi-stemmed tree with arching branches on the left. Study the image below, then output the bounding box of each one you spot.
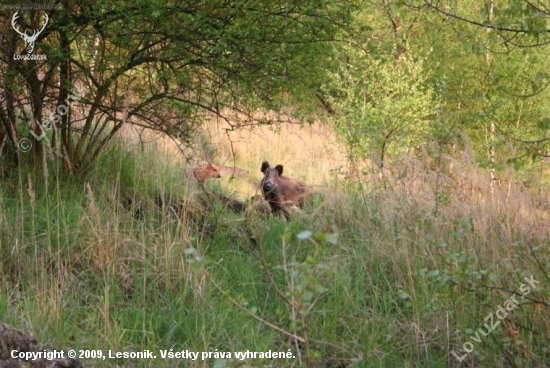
[0,0,348,173]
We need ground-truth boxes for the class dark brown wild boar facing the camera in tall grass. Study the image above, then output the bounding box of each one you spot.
[260,161,310,218]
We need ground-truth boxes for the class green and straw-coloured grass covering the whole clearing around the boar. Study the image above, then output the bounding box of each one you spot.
[0,123,550,367]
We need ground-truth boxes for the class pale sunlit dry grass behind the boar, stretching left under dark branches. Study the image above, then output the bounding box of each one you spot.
[117,115,345,199]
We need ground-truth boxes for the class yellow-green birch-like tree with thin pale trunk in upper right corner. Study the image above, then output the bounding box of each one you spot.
[405,0,550,166]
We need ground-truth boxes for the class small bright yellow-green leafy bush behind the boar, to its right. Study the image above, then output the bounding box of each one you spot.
[325,43,438,166]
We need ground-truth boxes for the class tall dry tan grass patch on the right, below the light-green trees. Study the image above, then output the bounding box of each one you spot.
[351,139,549,274]
